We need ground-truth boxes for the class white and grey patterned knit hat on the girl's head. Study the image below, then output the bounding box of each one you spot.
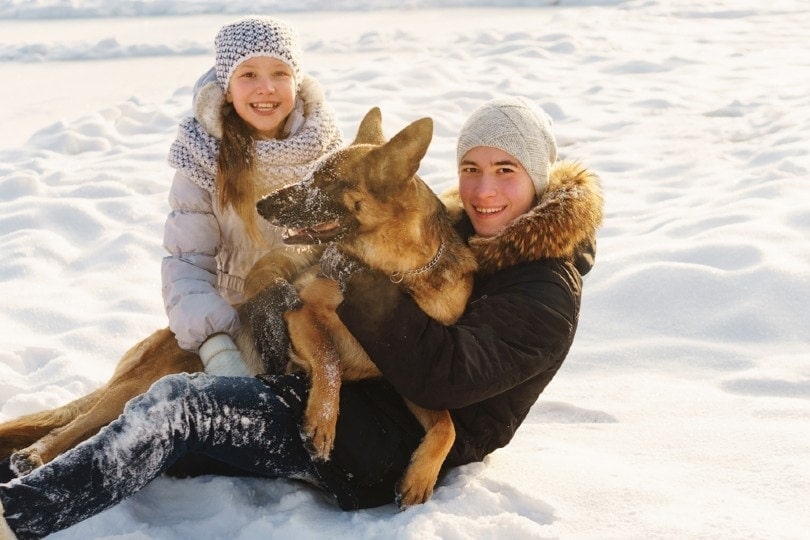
[214,17,301,90]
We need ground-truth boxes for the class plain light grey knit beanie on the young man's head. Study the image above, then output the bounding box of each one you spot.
[456,97,557,196]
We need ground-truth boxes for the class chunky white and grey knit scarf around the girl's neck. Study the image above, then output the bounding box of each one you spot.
[169,77,343,193]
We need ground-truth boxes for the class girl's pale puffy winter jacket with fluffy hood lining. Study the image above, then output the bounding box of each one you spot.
[161,70,342,352]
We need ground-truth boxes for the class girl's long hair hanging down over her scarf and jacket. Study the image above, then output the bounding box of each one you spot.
[216,101,265,244]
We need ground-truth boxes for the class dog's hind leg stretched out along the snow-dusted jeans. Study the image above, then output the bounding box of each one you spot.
[11,329,202,474]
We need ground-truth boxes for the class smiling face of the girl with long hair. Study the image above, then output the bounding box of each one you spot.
[225,56,296,139]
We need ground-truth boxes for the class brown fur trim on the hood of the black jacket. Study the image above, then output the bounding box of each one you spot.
[441,161,602,274]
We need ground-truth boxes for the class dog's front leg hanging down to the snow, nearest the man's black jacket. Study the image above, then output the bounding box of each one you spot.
[396,408,456,509]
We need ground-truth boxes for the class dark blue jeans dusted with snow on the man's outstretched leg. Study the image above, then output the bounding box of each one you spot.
[0,373,317,538]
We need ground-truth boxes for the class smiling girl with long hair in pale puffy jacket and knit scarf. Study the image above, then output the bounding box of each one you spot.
[162,17,343,375]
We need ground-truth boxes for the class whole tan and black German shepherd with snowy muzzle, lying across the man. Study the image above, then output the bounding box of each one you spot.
[0,108,476,507]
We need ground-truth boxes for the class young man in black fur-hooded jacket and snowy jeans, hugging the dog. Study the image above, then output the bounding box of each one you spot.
[0,98,602,540]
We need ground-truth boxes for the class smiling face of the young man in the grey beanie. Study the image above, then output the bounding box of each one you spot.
[458,146,536,236]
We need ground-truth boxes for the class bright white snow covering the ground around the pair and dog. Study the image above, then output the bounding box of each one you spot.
[0,0,810,540]
